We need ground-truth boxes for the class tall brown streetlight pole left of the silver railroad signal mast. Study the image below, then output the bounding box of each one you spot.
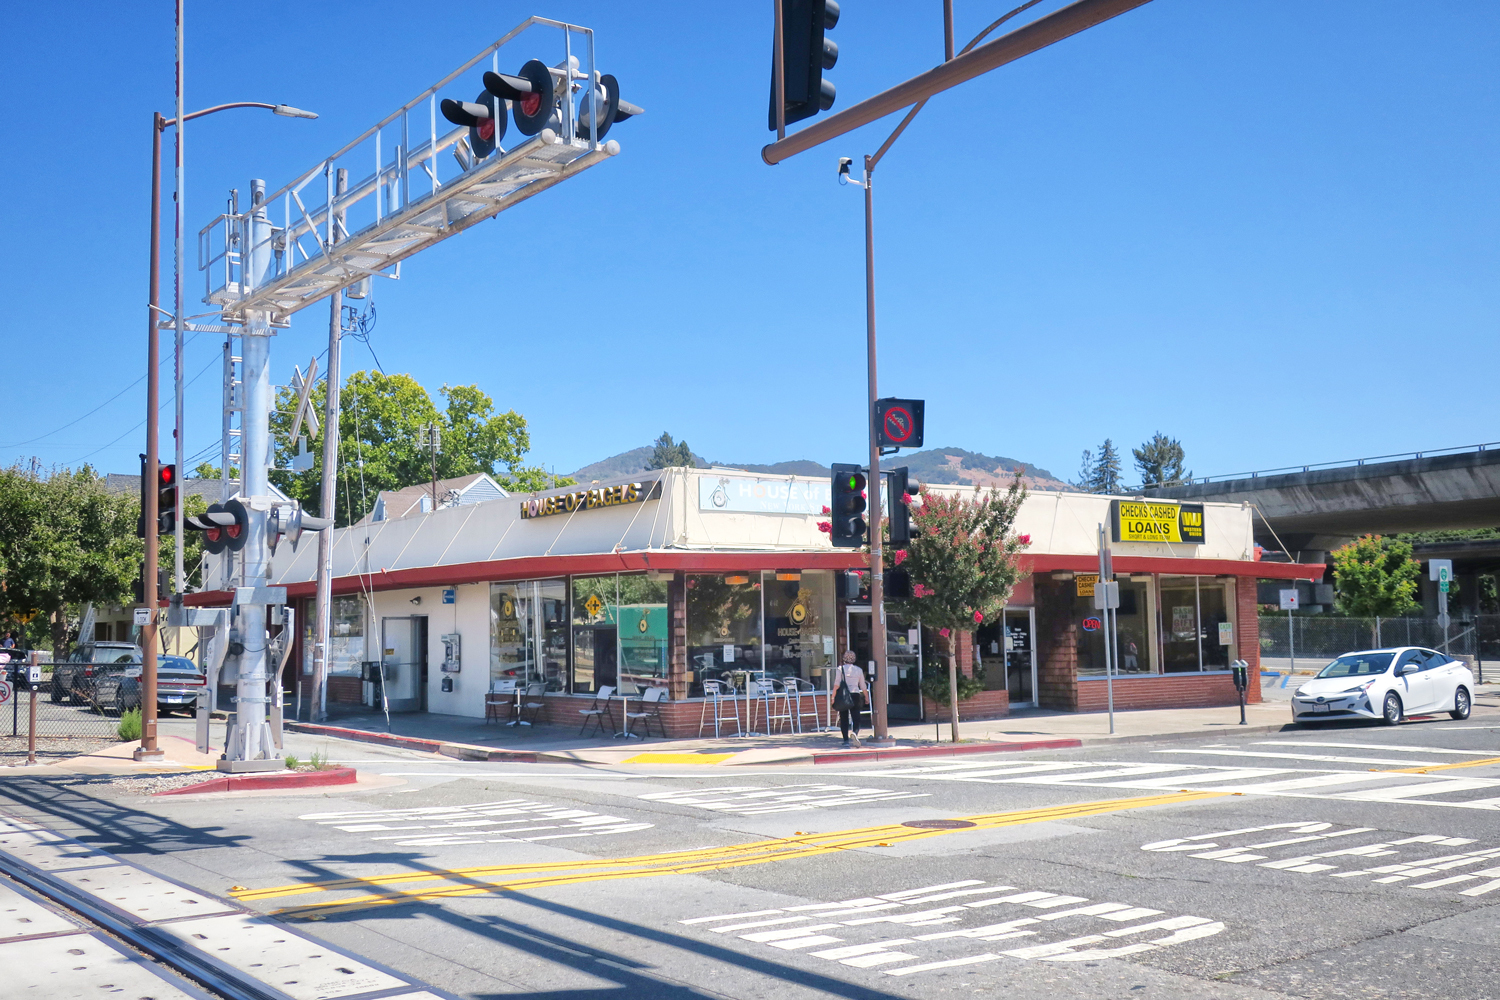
[137,112,166,760]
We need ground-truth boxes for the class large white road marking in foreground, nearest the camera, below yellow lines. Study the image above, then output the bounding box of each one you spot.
[680,879,1224,978]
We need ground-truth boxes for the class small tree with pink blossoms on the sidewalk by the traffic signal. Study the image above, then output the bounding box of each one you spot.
[885,475,1031,741]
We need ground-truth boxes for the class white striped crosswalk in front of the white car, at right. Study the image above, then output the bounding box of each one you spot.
[834,741,1500,811]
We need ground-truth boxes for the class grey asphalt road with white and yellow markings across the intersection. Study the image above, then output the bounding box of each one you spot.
[0,717,1500,1000]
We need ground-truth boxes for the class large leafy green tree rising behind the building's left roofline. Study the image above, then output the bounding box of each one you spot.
[272,372,573,526]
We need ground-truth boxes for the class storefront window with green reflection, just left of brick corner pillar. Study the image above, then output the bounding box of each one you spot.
[570,573,669,694]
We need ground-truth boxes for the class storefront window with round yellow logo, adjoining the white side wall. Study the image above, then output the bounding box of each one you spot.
[489,580,567,691]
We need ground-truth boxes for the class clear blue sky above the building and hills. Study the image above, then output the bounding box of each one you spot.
[0,0,1500,477]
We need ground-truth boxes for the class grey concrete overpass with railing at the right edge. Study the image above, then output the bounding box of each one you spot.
[1142,442,1500,562]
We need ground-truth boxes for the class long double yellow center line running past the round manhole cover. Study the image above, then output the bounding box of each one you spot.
[233,792,1223,919]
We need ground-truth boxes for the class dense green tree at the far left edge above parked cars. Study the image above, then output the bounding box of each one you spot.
[0,465,143,658]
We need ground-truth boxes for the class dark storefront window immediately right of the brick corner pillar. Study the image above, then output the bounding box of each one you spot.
[687,571,761,697]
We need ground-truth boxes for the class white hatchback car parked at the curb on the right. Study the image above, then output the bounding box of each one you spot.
[1292,646,1475,726]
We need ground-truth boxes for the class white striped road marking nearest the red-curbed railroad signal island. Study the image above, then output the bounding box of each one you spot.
[297,799,651,847]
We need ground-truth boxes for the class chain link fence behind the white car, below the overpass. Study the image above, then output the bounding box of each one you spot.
[1260,615,1500,683]
